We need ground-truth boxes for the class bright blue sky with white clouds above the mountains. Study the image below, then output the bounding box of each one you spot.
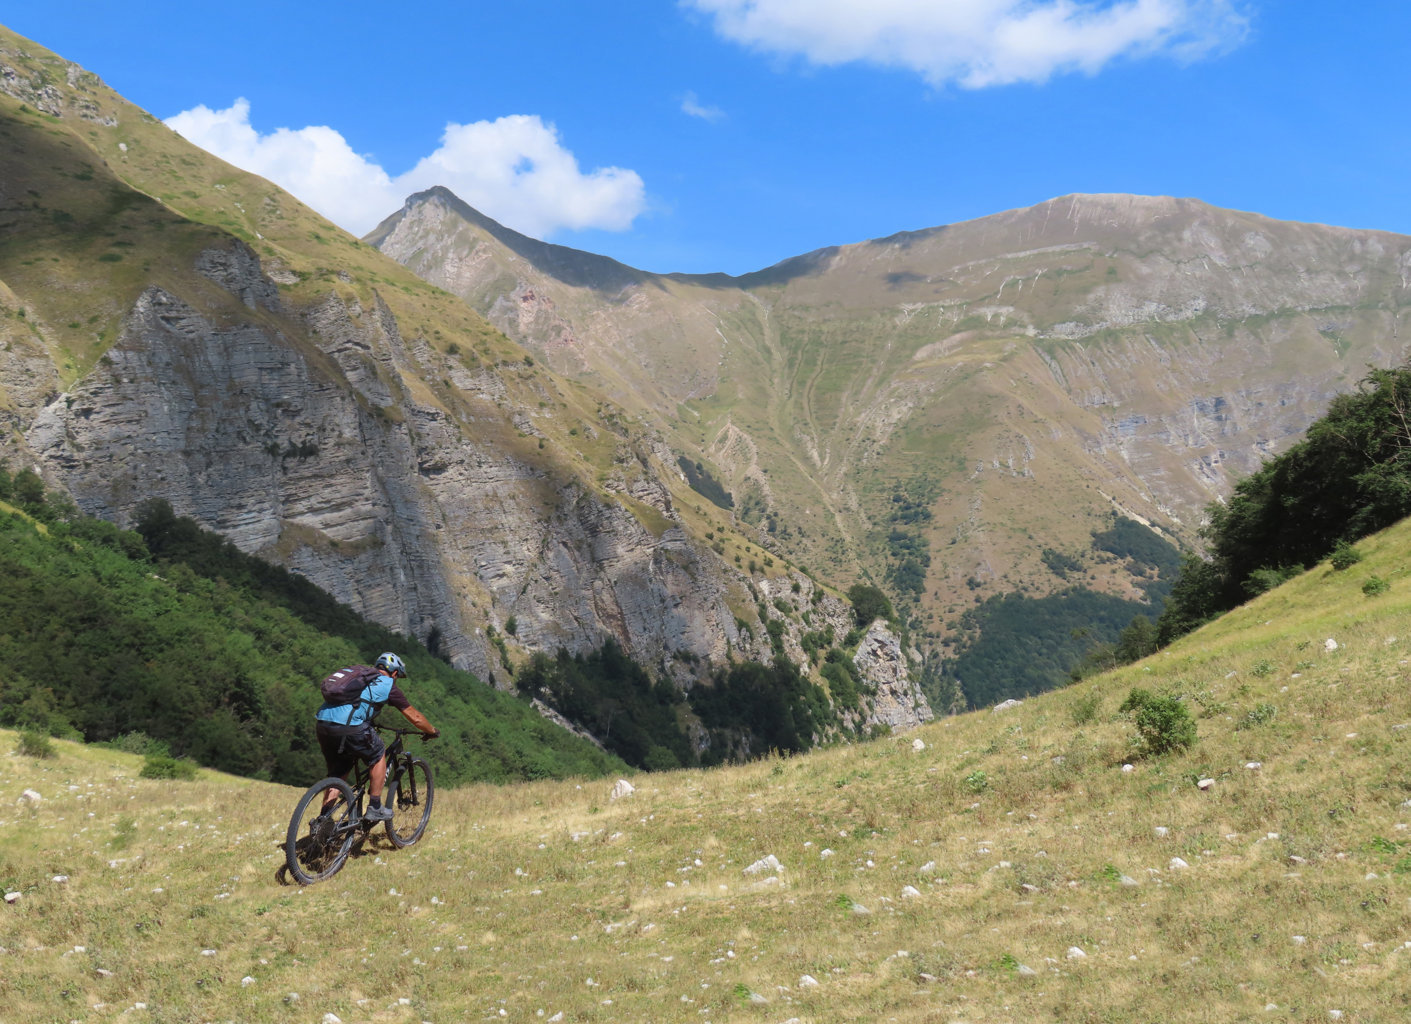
[11,0,1411,274]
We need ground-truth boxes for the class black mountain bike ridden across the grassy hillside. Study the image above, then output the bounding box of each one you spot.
[284,722,436,886]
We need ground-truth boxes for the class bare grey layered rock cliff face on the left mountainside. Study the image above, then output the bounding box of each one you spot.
[27,247,737,683]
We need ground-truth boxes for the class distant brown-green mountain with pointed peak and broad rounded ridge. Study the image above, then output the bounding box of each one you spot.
[368,190,1411,657]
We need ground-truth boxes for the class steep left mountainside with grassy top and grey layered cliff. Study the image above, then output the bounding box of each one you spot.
[0,30,936,727]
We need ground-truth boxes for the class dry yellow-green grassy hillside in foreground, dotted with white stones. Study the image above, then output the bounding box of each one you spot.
[0,523,1411,1023]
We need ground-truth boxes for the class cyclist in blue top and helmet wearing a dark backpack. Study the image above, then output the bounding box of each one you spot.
[315,652,440,822]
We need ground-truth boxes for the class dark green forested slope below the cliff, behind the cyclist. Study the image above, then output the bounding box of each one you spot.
[0,473,625,784]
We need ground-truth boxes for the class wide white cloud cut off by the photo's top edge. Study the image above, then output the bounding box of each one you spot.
[682,0,1249,89]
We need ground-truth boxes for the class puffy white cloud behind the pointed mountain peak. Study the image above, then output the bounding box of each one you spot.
[166,99,646,238]
